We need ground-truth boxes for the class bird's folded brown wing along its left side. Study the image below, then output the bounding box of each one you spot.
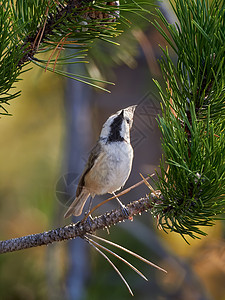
[76,142,101,197]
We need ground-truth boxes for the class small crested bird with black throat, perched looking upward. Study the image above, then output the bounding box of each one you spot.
[64,105,137,218]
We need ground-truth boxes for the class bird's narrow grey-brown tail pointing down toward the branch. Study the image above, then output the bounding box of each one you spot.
[64,188,90,218]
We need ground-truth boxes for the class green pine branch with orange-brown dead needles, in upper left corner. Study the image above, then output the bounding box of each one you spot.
[0,0,149,114]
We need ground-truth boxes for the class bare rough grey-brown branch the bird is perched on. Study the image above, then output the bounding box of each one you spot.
[0,193,161,254]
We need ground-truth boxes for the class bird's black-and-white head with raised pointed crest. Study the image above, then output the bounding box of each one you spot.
[100,105,137,143]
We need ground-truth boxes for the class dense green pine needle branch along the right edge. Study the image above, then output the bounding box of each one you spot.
[149,0,225,238]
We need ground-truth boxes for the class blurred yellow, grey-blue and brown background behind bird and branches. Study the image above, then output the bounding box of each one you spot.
[0,1,225,300]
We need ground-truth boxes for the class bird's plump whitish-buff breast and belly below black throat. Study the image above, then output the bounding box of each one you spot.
[85,142,133,195]
